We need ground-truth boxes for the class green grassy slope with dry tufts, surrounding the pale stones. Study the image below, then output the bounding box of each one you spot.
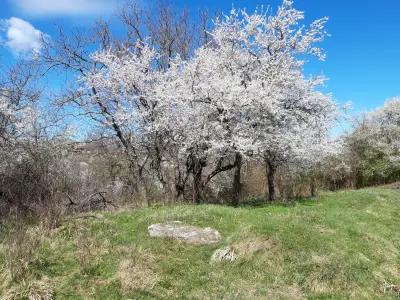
[0,188,400,299]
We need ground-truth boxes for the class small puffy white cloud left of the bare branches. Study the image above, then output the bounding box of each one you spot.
[3,17,43,54]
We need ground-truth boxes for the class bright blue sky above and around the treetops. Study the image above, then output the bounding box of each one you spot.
[0,0,400,116]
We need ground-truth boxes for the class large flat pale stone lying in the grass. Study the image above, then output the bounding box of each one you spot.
[148,221,221,244]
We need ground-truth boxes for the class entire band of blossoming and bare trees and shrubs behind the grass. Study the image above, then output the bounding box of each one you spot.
[0,0,400,225]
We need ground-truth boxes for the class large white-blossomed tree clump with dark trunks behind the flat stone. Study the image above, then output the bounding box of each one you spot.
[84,0,336,203]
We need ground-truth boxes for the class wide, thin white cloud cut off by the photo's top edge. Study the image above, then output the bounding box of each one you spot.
[13,0,118,17]
